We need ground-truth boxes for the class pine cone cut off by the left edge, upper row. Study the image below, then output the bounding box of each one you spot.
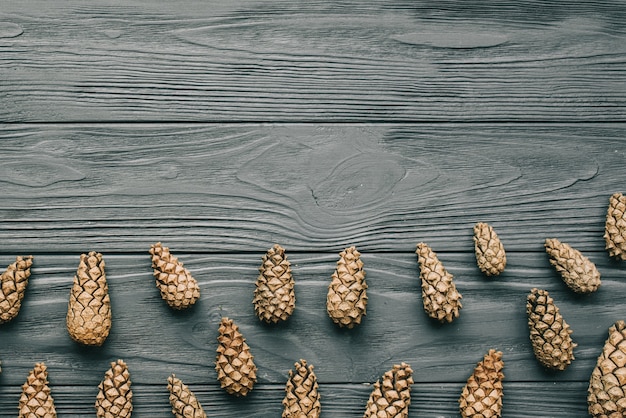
[0,255,33,324]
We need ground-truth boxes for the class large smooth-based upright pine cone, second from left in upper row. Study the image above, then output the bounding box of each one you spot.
[66,251,111,345]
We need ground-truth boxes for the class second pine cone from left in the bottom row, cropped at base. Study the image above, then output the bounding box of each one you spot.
[96,360,133,418]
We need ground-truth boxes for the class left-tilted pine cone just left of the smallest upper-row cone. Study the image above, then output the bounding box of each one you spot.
[415,242,463,322]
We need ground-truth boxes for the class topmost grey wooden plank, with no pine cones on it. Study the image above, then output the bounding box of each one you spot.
[0,0,626,122]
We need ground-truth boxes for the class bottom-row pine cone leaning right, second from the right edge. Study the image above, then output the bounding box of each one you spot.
[459,349,504,418]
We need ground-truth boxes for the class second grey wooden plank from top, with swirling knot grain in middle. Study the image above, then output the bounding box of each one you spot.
[0,124,626,254]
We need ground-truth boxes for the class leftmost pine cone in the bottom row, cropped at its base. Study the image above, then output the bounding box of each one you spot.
[18,363,57,418]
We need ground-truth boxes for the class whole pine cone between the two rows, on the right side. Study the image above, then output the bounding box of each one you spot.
[526,288,577,370]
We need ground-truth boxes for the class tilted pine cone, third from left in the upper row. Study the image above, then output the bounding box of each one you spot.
[150,242,200,310]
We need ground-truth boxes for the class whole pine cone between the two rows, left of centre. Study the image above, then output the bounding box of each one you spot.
[215,318,256,396]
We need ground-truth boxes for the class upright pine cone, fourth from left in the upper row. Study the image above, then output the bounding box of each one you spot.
[252,244,296,323]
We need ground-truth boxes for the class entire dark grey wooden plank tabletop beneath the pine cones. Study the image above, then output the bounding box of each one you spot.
[0,0,626,418]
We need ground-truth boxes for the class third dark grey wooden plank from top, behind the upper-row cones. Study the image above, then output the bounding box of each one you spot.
[0,251,626,388]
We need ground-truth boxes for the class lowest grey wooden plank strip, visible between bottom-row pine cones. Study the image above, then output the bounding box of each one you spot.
[0,381,587,418]
